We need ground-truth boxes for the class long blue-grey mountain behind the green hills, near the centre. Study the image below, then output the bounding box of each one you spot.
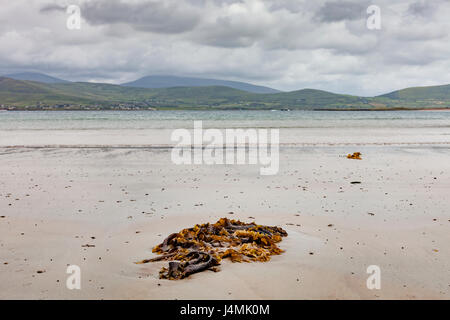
[122,76,281,93]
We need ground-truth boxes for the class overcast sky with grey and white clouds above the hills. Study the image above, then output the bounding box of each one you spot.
[0,0,450,96]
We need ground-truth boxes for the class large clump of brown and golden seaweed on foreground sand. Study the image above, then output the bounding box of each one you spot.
[137,218,287,280]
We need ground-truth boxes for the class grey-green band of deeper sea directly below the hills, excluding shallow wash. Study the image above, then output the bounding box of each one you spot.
[0,111,450,130]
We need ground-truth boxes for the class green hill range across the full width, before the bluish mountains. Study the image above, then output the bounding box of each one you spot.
[0,77,450,110]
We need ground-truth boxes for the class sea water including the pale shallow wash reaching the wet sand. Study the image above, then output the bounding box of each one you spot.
[0,110,450,146]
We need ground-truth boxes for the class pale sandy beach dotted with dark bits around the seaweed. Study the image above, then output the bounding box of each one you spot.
[0,132,450,299]
